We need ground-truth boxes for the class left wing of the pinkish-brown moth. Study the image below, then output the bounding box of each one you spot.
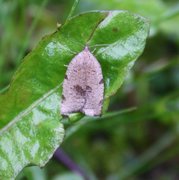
[61,52,85,115]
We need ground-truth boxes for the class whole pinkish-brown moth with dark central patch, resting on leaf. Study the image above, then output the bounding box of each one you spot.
[61,47,104,116]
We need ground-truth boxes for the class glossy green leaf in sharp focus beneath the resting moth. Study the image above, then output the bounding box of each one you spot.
[0,11,149,179]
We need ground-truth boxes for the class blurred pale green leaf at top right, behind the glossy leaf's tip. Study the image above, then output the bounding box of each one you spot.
[78,0,179,39]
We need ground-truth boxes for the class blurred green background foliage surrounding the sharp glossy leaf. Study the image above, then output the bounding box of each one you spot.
[0,0,179,180]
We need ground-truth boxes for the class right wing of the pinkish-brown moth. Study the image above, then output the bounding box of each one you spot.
[83,48,104,116]
